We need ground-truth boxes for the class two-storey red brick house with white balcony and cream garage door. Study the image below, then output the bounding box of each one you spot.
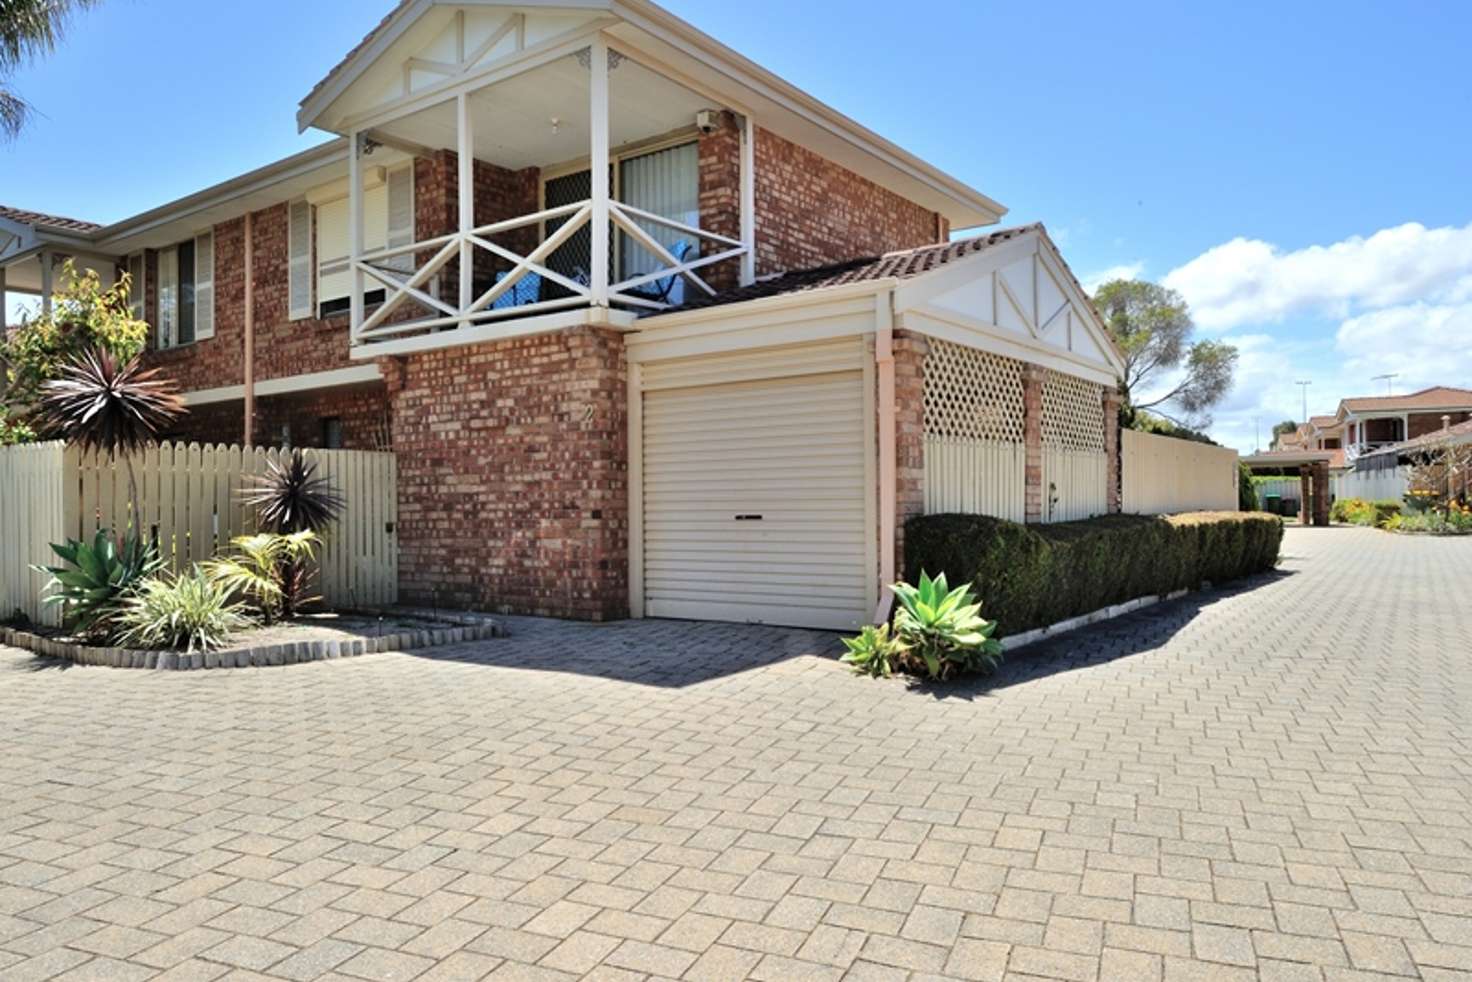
[0,0,1122,627]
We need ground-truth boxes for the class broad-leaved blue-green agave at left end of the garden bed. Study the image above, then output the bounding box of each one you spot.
[32,529,163,637]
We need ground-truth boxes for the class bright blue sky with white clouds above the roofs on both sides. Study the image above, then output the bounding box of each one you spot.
[0,0,1472,449]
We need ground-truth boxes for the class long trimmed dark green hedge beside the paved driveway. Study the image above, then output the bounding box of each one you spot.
[905,511,1284,636]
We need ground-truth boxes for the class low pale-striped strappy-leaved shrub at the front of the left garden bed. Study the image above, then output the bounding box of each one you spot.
[118,567,250,652]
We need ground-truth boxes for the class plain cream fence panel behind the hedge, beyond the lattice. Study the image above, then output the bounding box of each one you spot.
[1119,430,1238,515]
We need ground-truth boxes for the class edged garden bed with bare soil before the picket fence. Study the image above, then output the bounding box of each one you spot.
[0,608,505,670]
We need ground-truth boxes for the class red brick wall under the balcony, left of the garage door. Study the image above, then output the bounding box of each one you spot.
[384,328,629,620]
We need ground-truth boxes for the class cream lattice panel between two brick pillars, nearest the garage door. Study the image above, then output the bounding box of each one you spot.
[924,337,1023,443]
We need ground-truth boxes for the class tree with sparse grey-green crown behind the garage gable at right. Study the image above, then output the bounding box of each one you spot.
[1094,280,1236,428]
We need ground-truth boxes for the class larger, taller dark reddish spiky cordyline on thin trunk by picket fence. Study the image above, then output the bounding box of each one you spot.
[38,350,185,527]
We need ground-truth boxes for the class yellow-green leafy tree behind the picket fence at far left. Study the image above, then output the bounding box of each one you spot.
[0,260,149,429]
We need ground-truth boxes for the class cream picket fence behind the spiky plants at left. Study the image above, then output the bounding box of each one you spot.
[0,443,399,624]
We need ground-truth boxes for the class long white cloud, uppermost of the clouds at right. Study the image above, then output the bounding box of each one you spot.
[1163,222,1472,330]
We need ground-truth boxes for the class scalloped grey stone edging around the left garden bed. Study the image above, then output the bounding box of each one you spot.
[0,608,506,670]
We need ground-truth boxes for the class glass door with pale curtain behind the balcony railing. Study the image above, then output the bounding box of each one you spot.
[618,143,701,303]
